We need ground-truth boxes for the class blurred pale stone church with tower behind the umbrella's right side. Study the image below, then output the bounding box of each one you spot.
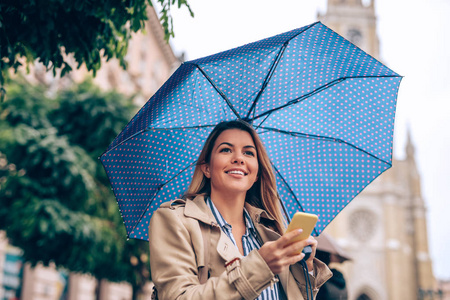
[318,0,436,300]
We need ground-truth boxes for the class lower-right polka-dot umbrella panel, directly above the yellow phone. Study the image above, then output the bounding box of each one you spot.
[259,129,390,235]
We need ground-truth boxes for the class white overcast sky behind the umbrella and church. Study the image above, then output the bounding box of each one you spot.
[161,0,450,279]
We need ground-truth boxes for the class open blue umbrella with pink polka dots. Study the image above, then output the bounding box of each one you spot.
[100,22,401,240]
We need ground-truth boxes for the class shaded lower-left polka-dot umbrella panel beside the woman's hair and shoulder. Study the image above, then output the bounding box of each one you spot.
[101,127,213,239]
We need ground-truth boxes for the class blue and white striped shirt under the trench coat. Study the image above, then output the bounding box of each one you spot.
[206,197,285,300]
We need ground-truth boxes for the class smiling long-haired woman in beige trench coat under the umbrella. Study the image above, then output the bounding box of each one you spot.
[149,121,331,300]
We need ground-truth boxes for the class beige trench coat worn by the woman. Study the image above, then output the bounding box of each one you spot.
[149,196,332,300]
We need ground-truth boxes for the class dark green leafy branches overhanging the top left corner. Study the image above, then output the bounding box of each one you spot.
[0,0,193,95]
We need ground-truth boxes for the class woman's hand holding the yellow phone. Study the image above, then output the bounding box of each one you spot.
[258,229,317,274]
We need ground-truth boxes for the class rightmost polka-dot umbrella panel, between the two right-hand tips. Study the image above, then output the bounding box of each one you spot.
[254,77,399,162]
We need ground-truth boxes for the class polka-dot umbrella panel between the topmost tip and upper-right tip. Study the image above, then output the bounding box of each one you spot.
[253,23,397,117]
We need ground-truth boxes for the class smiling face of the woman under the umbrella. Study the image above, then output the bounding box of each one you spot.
[202,129,258,195]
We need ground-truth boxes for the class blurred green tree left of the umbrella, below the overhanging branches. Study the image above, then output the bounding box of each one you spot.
[0,78,149,295]
